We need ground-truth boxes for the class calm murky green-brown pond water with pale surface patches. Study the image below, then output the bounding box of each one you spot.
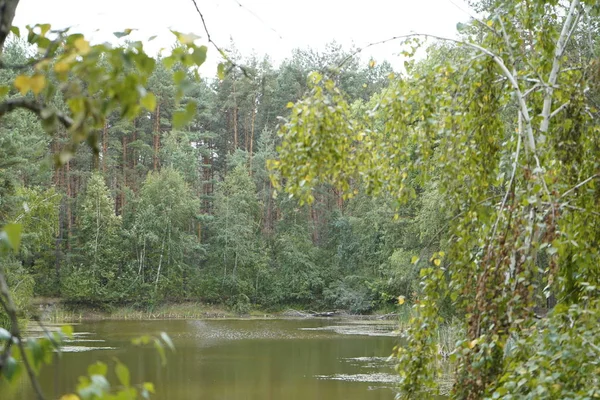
[0,319,397,400]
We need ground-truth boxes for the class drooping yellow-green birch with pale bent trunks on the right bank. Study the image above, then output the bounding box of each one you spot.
[271,1,598,399]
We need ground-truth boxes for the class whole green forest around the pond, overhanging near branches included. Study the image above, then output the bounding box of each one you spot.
[0,0,600,400]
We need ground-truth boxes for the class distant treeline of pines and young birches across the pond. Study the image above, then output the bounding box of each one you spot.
[0,41,444,312]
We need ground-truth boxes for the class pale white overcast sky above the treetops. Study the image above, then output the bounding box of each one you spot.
[14,0,470,71]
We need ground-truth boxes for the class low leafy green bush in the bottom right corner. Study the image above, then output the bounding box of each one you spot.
[490,300,600,399]
